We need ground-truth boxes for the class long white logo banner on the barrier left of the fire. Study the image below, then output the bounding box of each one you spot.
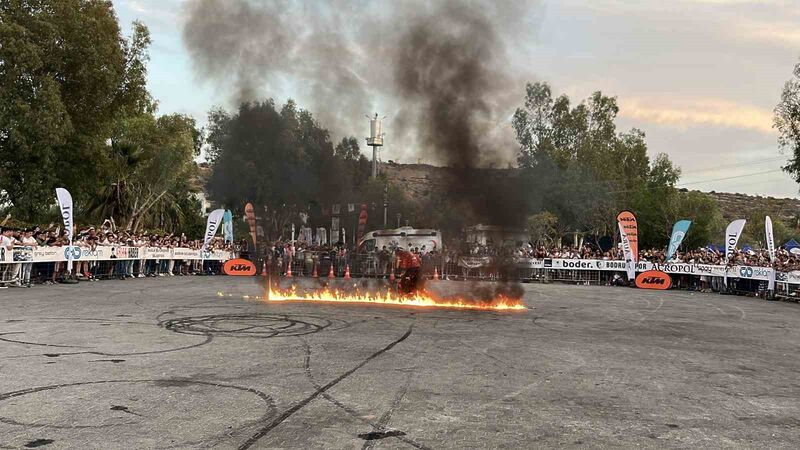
[0,245,234,263]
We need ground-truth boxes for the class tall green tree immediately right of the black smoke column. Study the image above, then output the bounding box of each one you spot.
[512,83,679,243]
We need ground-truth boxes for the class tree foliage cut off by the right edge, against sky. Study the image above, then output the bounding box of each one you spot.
[775,62,800,183]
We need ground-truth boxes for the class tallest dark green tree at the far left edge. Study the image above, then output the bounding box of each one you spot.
[0,0,153,220]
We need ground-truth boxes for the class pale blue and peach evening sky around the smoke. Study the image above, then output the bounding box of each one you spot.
[114,0,800,197]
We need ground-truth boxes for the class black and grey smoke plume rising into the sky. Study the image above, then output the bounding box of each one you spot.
[183,0,539,298]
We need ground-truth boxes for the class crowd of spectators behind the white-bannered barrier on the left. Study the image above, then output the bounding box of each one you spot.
[0,220,242,288]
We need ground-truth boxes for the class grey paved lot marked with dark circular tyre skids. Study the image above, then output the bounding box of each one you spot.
[0,277,800,450]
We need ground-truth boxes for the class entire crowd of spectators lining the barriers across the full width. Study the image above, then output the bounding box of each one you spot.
[6,220,800,287]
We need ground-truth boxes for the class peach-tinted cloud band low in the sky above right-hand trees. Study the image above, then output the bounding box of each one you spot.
[619,97,774,134]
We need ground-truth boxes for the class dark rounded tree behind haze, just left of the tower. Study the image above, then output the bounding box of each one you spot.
[206,100,372,239]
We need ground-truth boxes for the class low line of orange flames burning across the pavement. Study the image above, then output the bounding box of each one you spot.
[225,286,527,310]
